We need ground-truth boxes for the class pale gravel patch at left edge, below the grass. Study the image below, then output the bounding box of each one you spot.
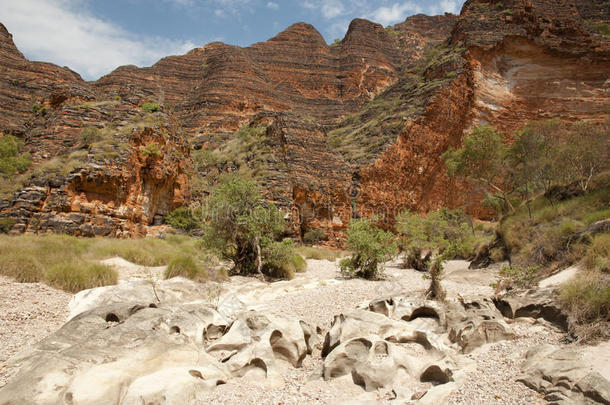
[0,276,72,387]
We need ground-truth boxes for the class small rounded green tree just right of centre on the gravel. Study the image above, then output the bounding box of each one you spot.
[340,218,398,279]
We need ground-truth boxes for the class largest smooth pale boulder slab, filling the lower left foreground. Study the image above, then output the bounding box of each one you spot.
[0,301,316,404]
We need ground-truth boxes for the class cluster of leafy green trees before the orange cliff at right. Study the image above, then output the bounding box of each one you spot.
[443,120,610,215]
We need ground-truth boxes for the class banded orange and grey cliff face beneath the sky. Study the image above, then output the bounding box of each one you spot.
[0,0,610,240]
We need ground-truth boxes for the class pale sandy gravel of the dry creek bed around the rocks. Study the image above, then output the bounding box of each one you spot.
[0,258,562,404]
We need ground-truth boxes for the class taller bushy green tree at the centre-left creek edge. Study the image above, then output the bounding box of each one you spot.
[204,177,285,275]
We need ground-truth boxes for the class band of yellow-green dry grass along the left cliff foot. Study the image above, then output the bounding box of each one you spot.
[0,235,218,292]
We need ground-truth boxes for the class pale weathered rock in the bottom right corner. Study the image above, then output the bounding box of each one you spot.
[518,345,610,404]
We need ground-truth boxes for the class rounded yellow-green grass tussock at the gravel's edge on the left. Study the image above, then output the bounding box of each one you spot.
[44,261,118,292]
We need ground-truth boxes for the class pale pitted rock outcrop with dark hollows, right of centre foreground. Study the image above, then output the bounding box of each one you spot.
[322,297,513,401]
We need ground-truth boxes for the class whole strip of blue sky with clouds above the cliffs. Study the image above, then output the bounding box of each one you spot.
[0,0,464,80]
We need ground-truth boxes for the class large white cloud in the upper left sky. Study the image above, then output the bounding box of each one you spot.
[0,0,195,79]
